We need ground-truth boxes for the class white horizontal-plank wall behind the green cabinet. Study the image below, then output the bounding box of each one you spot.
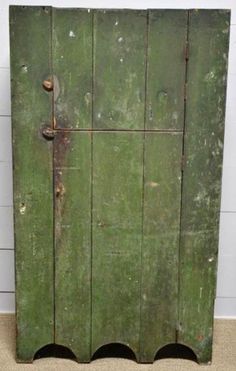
[0,0,236,317]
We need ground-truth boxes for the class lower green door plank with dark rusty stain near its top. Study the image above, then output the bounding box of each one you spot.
[54,131,91,362]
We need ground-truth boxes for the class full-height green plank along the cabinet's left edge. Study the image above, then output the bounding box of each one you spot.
[10,6,54,361]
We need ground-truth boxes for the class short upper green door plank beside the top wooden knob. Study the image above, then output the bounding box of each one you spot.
[52,8,92,129]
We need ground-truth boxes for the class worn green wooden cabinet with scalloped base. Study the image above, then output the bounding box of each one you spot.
[10,6,229,363]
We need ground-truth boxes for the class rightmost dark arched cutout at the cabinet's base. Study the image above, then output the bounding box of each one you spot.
[155,343,198,363]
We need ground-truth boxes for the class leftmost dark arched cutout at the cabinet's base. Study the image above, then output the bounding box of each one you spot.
[34,344,76,361]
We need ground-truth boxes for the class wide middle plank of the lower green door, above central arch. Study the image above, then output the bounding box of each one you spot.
[92,132,143,355]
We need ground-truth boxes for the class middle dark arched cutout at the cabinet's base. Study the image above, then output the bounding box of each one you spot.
[92,343,136,361]
